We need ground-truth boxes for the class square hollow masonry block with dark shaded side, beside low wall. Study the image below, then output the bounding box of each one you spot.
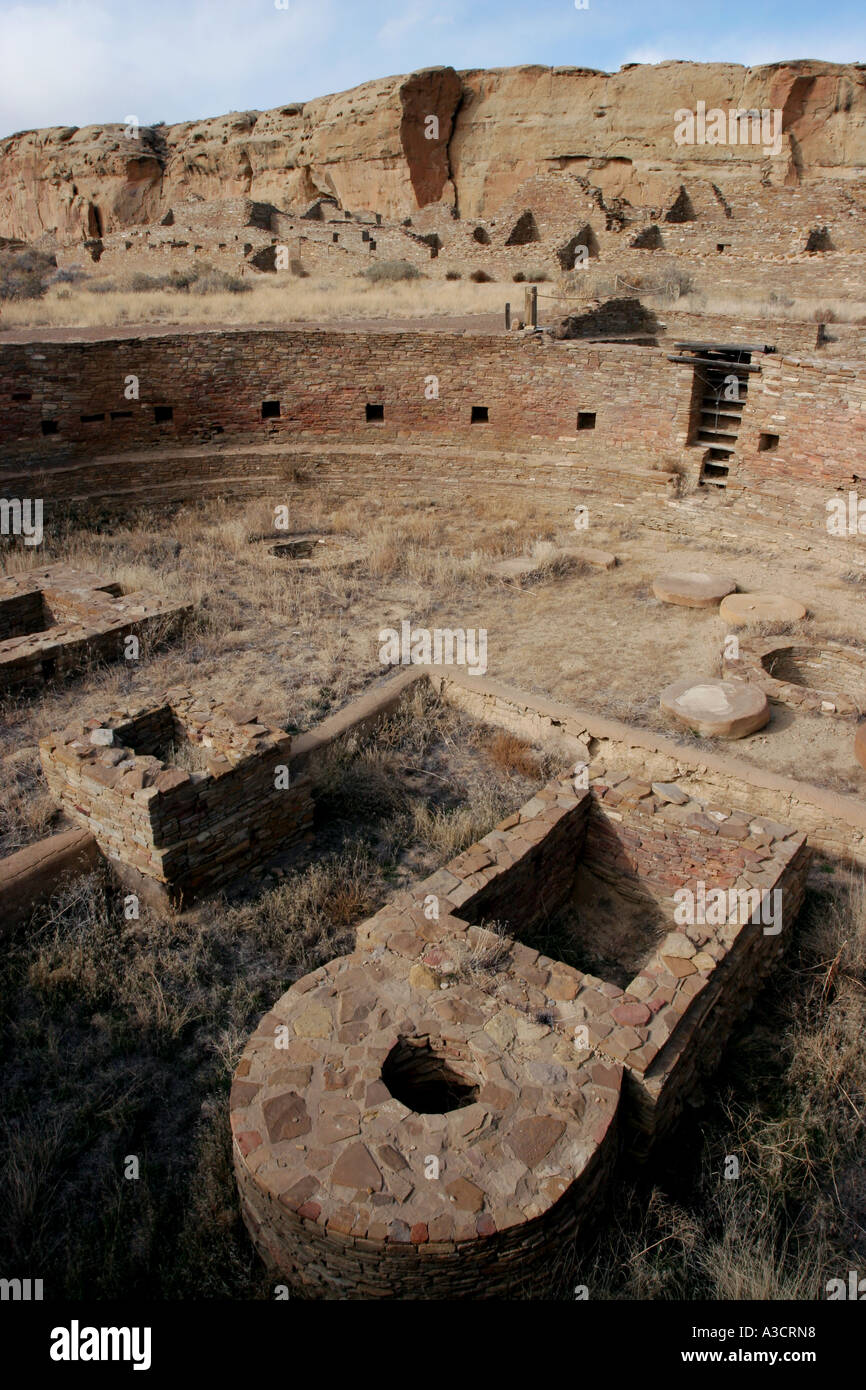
[39,688,313,898]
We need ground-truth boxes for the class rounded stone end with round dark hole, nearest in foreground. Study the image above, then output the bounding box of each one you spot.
[231,952,621,1298]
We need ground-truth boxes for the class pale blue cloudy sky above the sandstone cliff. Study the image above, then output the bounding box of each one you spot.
[0,0,866,135]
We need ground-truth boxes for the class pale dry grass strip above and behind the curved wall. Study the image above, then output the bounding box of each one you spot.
[3,274,503,329]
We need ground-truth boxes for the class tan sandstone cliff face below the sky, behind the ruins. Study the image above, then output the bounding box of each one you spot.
[0,61,866,240]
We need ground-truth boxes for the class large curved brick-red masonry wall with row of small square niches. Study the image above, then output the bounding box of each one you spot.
[0,329,866,519]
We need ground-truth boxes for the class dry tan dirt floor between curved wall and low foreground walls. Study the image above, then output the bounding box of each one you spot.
[0,487,866,852]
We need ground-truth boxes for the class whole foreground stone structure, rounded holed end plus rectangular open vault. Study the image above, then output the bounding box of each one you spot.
[231,770,808,1298]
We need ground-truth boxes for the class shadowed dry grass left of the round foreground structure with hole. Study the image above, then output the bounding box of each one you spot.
[0,689,553,1298]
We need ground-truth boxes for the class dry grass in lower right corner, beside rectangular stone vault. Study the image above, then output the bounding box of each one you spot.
[567,876,866,1301]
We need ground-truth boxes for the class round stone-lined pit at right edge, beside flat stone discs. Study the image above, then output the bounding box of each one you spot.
[724,637,866,717]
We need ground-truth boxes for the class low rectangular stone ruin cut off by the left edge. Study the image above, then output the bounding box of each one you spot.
[0,564,192,692]
